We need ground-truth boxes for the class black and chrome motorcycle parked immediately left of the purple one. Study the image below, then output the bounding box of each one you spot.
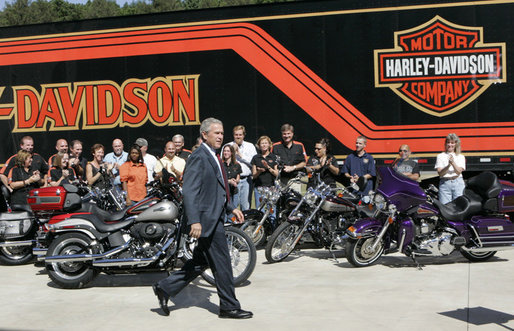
[265,174,365,263]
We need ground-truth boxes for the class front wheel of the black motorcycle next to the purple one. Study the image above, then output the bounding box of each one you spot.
[265,222,301,263]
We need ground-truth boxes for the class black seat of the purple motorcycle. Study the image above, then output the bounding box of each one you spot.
[434,190,482,222]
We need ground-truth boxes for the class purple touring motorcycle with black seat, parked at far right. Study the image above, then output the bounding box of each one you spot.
[345,167,514,267]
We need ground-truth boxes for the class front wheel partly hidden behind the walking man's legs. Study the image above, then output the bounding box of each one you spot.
[183,226,257,286]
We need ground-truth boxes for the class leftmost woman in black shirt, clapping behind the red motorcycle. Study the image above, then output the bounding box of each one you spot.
[8,150,44,205]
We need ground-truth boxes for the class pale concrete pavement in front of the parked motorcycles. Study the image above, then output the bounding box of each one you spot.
[0,250,514,331]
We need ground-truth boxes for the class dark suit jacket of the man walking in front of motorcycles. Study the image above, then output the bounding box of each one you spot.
[182,144,234,237]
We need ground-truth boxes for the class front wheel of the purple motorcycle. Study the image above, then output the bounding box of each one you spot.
[345,237,384,267]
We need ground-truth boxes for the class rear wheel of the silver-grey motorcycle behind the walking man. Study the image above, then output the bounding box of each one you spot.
[46,233,98,289]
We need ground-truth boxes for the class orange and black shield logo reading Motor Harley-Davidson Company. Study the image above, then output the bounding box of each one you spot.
[375,16,507,116]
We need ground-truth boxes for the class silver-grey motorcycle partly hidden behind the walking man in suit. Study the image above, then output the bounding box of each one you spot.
[45,172,256,288]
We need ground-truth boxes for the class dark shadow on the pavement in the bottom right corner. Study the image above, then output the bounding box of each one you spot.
[438,306,514,330]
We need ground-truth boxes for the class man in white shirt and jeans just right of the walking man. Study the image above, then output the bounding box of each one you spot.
[231,125,257,210]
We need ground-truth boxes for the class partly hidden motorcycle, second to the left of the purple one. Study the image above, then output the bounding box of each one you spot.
[241,174,304,247]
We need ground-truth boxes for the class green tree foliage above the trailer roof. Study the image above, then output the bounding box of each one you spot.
[0,0,295,26]
